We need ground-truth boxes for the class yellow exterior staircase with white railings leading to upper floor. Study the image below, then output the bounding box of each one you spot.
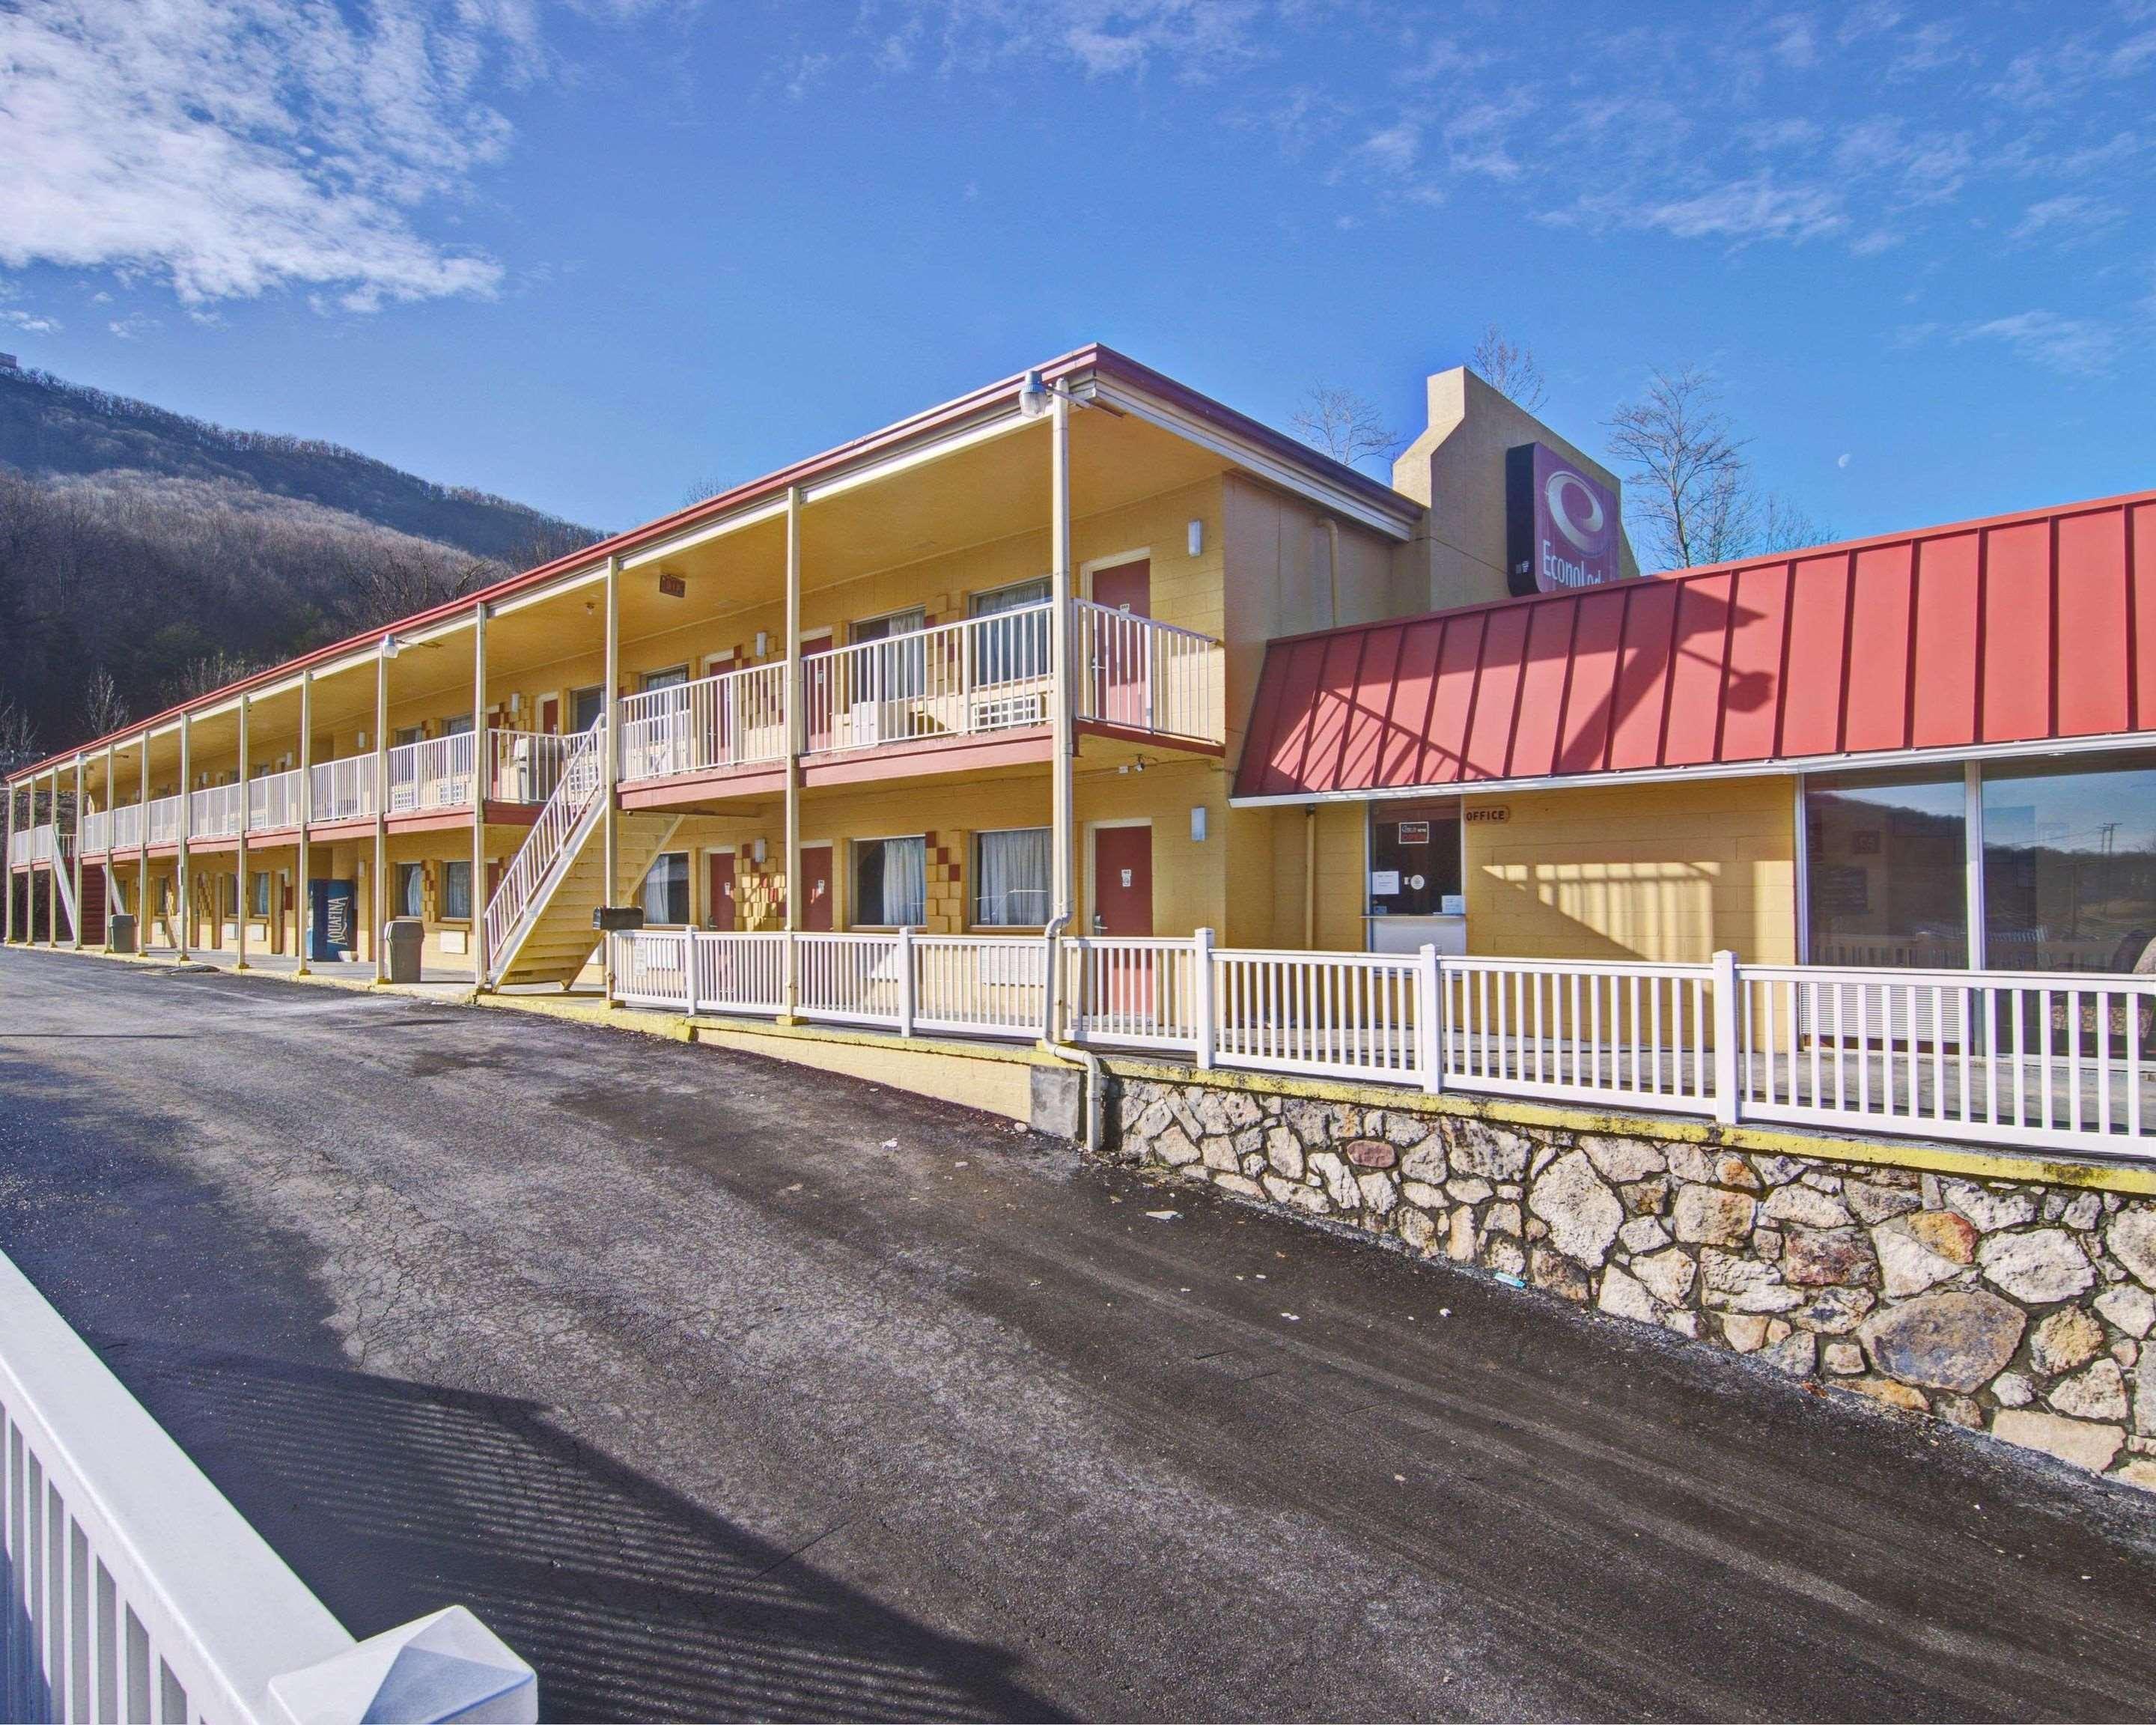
[487,718,681,988]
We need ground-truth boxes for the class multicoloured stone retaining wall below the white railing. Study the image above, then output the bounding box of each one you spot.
[1106,1074,2156,1490]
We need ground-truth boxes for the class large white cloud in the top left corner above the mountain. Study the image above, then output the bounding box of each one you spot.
[0,0,541,310]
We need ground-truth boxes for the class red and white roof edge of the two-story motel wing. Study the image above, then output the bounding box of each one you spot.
[7,341,1421,785]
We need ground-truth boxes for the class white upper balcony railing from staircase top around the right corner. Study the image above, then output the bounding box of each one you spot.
[621,600,1222,785]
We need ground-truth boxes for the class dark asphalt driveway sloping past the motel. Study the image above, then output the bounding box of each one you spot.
[0,951,2156,1718]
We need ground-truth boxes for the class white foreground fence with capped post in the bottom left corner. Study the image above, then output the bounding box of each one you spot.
[0,1257,539,1725]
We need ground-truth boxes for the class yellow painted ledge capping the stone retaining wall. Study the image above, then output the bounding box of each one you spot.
[1102,1054,2156,1196]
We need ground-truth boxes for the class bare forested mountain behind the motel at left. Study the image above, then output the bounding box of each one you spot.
[0,371,600,759]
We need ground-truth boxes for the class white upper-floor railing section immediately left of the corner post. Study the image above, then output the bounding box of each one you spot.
[802,606,1054,755]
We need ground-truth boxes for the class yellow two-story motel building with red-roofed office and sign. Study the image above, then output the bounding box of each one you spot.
[7,347,2156,1137]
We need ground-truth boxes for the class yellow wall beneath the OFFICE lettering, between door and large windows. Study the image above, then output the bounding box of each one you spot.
[1466,779,1796,964]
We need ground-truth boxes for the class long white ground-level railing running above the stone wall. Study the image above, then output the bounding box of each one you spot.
[615,929,2156,1156]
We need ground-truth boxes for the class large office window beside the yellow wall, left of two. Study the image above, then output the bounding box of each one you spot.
[1805,765,1968,970]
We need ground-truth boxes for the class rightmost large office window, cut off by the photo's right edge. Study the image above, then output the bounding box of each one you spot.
[1984,755,2156,973]
